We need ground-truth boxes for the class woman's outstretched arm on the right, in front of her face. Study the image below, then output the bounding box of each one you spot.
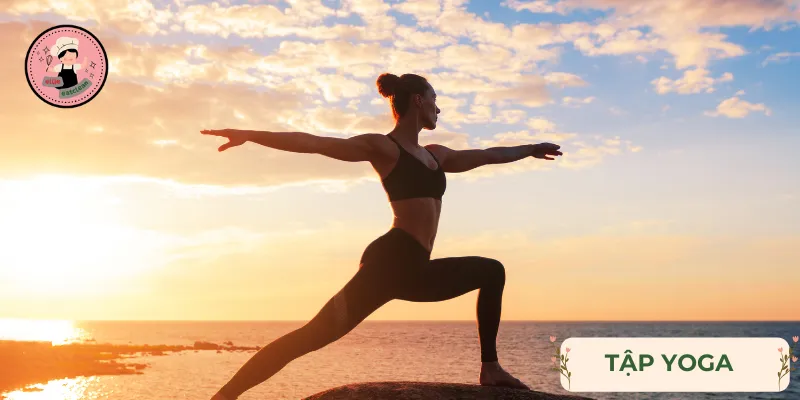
[426,143,561,172]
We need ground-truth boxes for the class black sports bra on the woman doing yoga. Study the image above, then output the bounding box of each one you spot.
[381,135,447,201]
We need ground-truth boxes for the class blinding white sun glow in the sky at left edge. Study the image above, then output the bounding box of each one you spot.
[0,176,165,294]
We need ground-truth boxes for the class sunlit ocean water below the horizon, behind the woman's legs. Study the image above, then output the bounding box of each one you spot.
[0,320,800,400]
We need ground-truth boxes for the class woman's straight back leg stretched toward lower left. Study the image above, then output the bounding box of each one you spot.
[215,269,391,400]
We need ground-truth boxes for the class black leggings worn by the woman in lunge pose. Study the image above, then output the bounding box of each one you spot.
[220,228,505,400]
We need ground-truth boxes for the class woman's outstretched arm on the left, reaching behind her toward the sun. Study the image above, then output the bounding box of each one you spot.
[200,129,381,162]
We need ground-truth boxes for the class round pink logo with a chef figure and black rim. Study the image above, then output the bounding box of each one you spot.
[25,25,108,108]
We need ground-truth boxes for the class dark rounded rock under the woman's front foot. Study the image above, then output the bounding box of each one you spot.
[305,382,590,400]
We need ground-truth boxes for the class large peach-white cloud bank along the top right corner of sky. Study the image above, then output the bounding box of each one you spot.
[504,0,800,69]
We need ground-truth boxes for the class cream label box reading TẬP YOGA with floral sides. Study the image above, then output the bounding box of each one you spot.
[551,337,798,392]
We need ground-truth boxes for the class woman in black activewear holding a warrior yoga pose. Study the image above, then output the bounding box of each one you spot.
[202,73,561,400]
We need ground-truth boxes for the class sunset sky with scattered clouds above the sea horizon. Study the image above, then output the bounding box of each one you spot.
[0,0,800,321]
